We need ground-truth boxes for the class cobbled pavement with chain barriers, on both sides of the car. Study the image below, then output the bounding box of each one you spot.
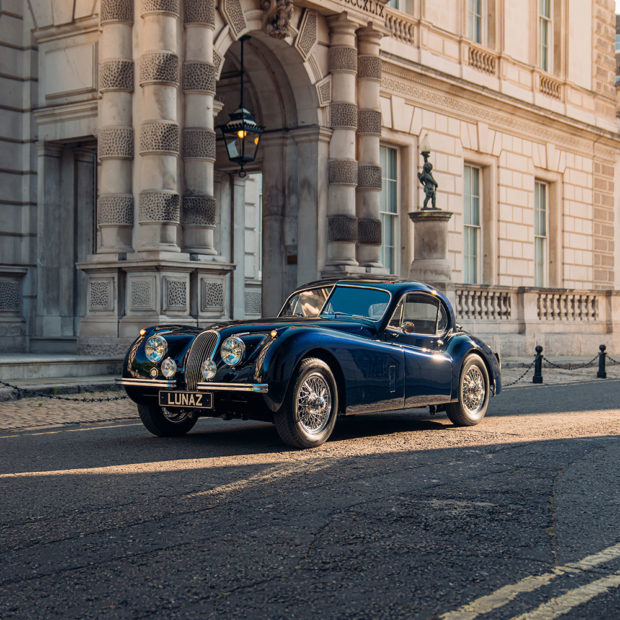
[0,357,620,430]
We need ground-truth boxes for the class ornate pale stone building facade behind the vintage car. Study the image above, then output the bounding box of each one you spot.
[0,0,620,355]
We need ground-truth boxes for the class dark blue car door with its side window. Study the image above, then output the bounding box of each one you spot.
[386,292,452,407]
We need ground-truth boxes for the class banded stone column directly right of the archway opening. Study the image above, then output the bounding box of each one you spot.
[325,13,358,273]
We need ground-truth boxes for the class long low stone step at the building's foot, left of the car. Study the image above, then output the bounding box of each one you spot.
[0,353,123,383]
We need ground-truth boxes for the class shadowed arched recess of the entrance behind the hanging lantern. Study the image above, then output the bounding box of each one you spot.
[214,21,327,318]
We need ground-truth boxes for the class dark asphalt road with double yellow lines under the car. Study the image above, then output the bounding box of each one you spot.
[0,380,620,620]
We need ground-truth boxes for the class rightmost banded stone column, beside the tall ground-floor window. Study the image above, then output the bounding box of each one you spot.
[356,27,385,273]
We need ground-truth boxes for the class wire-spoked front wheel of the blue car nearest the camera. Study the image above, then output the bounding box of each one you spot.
[274,358,338,448]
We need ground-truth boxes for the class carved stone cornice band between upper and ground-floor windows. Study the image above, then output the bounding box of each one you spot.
[381,52,620,152]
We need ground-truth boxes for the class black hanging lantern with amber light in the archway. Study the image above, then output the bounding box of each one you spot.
[219,36,265,177]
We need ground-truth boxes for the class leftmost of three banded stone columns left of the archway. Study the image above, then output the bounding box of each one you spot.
[97,0,134,254]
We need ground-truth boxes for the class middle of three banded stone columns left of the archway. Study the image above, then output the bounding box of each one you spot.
[138,0,181,252]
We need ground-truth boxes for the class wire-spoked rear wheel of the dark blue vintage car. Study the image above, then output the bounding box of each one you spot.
[446,354,489,426]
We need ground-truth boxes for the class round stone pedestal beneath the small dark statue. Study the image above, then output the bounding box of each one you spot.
[409,210,453,284]
